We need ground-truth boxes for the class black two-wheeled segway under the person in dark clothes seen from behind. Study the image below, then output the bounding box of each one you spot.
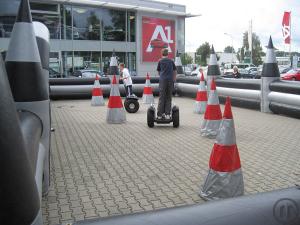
[147,105,179,128]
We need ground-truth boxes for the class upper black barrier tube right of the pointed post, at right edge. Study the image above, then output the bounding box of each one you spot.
[270,80,300,95]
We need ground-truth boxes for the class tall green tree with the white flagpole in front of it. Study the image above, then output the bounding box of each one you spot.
[241,31,264,66]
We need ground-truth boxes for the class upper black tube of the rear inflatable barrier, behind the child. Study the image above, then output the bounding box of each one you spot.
[49,77,159,86]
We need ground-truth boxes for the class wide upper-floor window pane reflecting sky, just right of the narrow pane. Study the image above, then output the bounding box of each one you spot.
[73,7,100,40]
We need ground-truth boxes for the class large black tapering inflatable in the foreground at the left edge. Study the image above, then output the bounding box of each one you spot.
[0,53,40,225]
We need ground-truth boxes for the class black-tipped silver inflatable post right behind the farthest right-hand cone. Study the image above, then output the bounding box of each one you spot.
[206,45,221,92]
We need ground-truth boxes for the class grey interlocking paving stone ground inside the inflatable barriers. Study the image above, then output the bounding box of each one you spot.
[42,98,300,224]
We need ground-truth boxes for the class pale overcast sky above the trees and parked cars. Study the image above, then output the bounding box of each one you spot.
[160,0,300,52]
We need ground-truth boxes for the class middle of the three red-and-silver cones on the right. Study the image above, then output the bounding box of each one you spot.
[200,79,222,138]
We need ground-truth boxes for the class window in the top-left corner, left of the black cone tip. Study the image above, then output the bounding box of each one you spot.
[0,0,20,38]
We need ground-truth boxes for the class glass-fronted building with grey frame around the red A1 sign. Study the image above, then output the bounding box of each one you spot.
[0,0,185,77]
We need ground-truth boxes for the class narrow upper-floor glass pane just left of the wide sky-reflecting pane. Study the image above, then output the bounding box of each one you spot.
[60,5,72,40]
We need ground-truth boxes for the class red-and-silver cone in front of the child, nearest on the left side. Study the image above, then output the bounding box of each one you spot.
[106,75,126,123]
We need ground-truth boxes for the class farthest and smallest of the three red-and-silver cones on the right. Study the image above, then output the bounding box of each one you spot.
[194,73,207,114]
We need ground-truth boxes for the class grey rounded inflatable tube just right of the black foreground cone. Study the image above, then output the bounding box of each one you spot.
[18,111,42,174]
